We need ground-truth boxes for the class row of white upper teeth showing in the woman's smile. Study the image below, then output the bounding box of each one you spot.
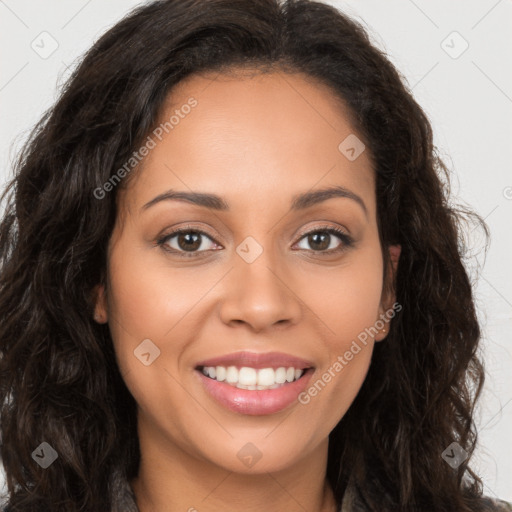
[202,366,305,390]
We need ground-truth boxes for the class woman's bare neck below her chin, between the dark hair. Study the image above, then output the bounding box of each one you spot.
[130,416,338,512]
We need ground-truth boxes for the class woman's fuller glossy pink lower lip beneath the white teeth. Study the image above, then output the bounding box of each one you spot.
[195,368,314,416]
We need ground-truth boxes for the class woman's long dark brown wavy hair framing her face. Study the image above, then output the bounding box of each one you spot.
[0,0,488,512]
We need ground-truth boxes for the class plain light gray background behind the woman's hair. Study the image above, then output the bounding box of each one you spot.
[0,0,512,500]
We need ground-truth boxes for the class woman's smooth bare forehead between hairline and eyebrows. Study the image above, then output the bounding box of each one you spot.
[120,71,375,218]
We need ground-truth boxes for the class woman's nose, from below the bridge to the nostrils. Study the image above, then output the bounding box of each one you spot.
[220,251,302,332]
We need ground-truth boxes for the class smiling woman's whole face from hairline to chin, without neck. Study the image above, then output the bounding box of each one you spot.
[97,73,400,473]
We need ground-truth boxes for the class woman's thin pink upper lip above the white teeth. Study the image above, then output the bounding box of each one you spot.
[196,351,313,370]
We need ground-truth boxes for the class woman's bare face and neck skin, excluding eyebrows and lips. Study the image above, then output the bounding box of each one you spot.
[96,72,399,512]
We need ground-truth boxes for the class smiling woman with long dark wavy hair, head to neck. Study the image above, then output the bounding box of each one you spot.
[0,0,508,512]
